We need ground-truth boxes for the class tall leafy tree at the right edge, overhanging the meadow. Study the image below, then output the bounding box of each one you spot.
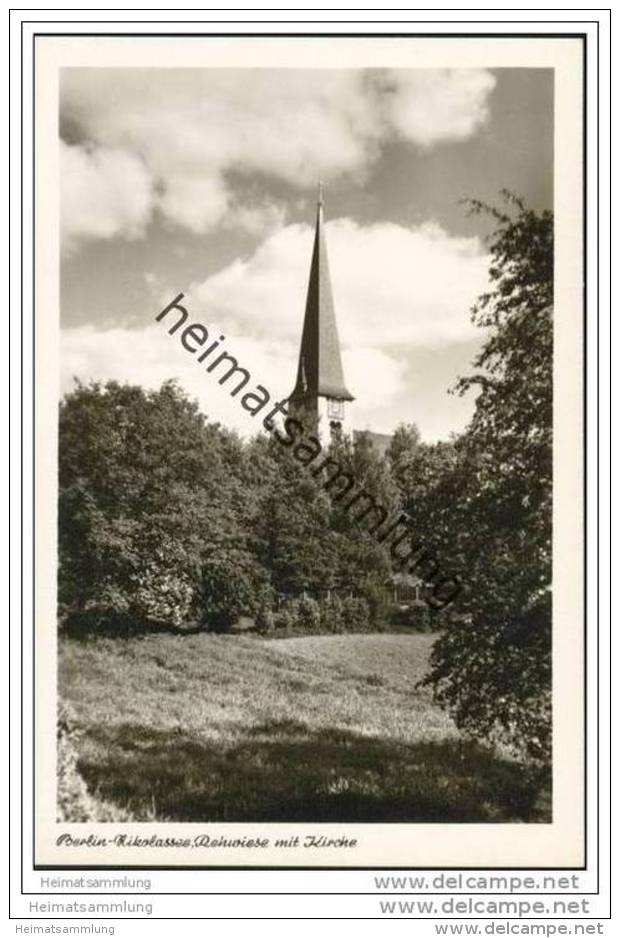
[426,193,553,761]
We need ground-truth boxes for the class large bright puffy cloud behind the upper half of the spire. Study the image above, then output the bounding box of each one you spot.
[191,219,488,350]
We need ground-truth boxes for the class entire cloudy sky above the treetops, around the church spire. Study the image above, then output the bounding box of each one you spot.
[59,68,553,441]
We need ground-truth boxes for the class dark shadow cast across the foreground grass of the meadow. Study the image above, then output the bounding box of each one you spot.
[79,721,550,822]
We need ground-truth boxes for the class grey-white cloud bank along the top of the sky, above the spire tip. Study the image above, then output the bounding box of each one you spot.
[61,68,495,249]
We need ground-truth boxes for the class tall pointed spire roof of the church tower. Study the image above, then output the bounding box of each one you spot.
[291,184,355,401]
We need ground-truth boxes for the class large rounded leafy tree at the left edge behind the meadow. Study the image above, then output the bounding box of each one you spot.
[59,381,262,627]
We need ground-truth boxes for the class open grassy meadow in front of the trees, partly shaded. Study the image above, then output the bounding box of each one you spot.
[59,634,549,822]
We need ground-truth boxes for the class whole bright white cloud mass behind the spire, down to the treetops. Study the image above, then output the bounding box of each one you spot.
[61,219,488,438]
